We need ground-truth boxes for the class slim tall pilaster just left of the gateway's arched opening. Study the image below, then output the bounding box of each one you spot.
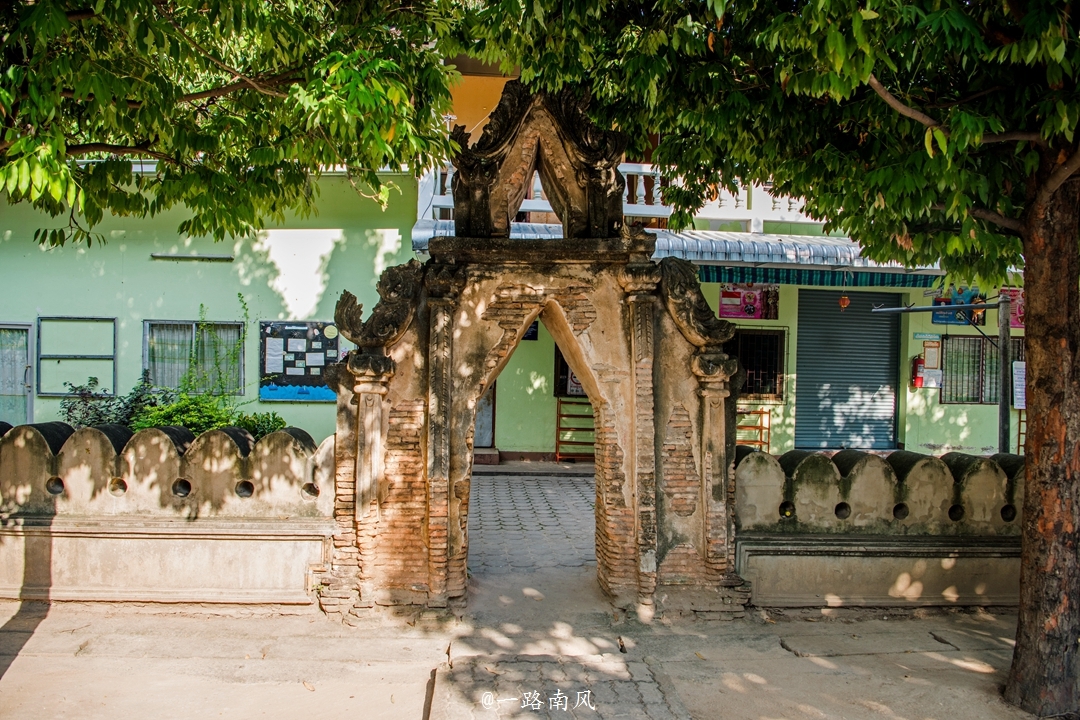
[427,298,454,608]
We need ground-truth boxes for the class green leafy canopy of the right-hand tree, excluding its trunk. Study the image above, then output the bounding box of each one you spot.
[467,0,1080,280]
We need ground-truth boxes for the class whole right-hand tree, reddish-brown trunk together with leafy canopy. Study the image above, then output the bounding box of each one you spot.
[460,0,1080,716]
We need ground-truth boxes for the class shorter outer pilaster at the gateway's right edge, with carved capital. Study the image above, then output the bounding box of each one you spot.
[691,349,741,582]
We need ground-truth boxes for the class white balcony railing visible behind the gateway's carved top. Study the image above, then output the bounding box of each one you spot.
[418,163,813,232]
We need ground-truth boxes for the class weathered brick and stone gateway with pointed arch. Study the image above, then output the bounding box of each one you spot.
[320,82,748,617]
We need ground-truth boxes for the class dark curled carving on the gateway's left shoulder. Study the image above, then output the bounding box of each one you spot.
[334,259,422,354]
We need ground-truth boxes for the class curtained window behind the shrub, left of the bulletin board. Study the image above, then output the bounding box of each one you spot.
[143,320,244,395]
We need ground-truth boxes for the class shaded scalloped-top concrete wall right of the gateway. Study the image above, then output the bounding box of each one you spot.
[735,448,1024,607]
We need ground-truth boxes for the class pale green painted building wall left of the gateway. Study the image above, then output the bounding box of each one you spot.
[0,175,417,441]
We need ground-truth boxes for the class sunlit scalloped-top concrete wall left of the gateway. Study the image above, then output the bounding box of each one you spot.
[0,422,335,603]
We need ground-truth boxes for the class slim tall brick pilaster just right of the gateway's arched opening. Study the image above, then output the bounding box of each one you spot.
[619,262,660,606]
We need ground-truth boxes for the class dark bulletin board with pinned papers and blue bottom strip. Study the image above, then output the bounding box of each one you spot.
[259,321,338,403]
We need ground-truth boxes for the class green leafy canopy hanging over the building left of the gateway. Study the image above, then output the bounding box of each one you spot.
[0,0,454,245]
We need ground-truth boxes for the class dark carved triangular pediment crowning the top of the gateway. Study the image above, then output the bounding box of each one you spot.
[450,80,626,237]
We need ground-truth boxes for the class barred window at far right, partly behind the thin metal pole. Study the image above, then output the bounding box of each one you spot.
[940,336,1024,405]
